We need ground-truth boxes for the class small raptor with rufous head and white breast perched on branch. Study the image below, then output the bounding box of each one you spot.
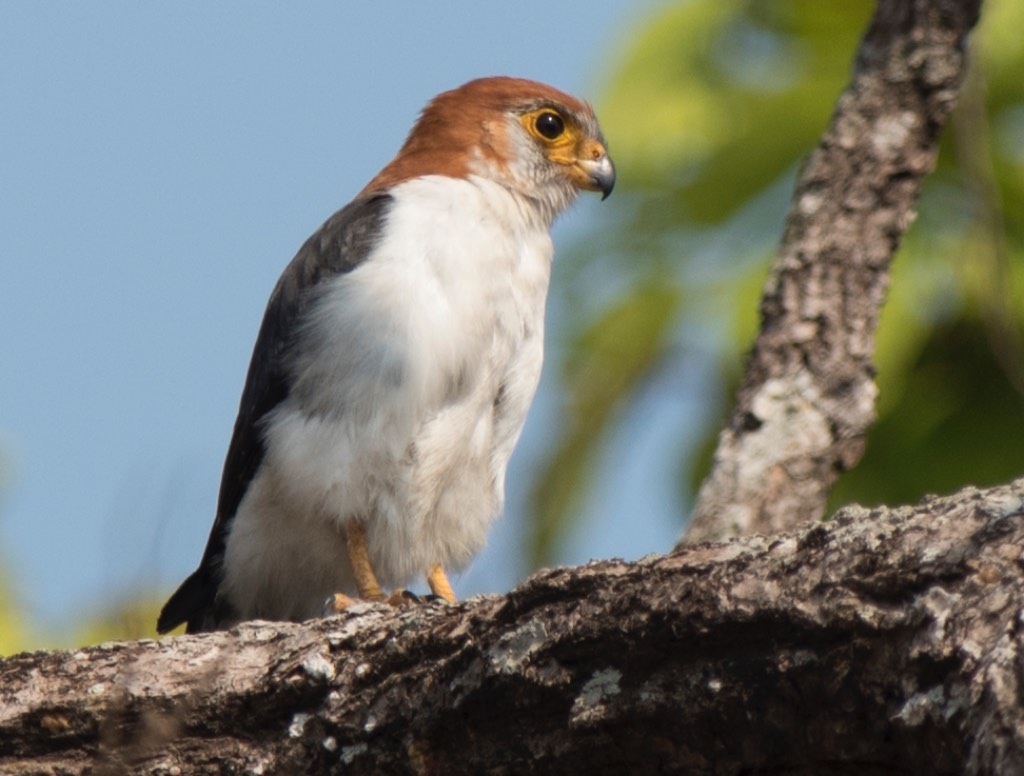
[157,76,615,634]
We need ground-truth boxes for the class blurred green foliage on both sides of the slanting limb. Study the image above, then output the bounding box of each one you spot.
[529,0,1024,565]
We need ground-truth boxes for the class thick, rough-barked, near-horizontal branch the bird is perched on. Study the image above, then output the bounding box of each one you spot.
[6,479,1024,775]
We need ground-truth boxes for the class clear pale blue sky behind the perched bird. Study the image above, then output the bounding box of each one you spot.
[0,0,679,642]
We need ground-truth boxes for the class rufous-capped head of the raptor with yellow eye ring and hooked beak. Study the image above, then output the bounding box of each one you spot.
[364,77,615,223]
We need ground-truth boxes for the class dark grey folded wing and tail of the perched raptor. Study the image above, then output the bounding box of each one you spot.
[157,195,391,633]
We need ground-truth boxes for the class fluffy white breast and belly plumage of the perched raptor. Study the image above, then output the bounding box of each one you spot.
[223,176,552,618]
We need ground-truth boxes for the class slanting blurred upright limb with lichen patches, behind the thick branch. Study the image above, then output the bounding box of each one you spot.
[684,0,980,542]
